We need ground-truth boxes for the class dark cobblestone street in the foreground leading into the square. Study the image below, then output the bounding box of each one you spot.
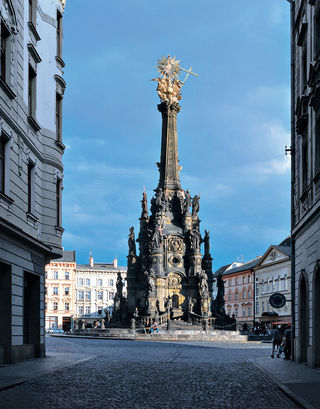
[0,337,297,409]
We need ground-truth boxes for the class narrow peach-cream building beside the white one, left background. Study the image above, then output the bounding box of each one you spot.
[44,251,76,331]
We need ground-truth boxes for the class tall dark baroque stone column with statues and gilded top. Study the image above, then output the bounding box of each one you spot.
[127,56,213,320]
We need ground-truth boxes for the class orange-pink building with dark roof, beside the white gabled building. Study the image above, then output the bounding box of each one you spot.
[222,257,260,325]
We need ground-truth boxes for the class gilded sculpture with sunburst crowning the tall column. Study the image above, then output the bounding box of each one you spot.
[152,55,198,104]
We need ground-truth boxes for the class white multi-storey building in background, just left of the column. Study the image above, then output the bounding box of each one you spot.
[75,255,127,324]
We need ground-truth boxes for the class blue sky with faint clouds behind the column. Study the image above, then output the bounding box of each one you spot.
[63,0,290,270]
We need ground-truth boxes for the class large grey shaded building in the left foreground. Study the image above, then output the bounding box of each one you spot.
[0,0,65,362]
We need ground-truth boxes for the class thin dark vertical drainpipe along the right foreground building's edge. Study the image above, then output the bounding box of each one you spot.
[287,0,296,360]
